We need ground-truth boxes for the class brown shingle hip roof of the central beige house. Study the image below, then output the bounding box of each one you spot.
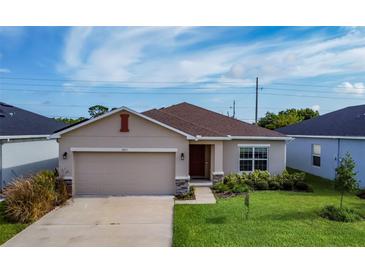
[143,102,285,137]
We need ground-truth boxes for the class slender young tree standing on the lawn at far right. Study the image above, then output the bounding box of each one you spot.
[335,153,359,208]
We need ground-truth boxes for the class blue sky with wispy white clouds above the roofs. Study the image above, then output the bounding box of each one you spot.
[0,27,365,122]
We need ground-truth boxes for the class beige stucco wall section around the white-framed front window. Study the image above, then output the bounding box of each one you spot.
[223,140,286,174]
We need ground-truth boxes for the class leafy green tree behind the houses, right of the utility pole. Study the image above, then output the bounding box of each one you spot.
[258,108,319,129]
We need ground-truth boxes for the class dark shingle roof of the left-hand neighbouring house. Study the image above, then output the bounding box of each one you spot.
[0,102,65,136]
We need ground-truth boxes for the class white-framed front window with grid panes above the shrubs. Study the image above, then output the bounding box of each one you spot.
[240,147,268,171]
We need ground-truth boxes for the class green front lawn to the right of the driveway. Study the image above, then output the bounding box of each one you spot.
[173,169,365,246]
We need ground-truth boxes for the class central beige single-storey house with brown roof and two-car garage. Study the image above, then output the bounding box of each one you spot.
[52,103,289,195]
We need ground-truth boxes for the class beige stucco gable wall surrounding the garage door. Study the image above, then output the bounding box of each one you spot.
[59,112,189,177]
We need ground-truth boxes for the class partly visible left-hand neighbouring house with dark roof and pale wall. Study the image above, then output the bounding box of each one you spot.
[0,102,65,188]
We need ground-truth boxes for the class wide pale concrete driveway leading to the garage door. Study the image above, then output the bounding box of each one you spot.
[4,196,174,246]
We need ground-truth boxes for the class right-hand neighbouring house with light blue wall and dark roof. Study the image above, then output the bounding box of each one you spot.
[277,105,365,187]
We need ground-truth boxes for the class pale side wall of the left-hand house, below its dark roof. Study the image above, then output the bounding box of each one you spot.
[0,140,58,186]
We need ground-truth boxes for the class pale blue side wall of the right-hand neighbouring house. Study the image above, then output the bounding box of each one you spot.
[287,137,365,187]
